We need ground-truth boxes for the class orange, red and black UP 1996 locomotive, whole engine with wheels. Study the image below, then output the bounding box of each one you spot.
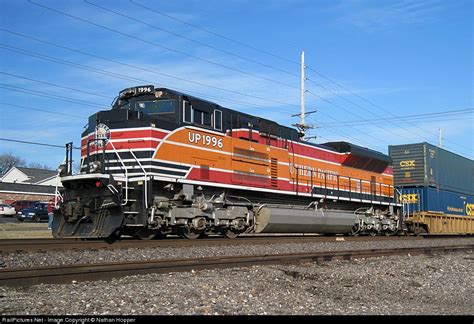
[53,85,400,239]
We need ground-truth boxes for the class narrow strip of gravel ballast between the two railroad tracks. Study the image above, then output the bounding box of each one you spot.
[0,238,474,268]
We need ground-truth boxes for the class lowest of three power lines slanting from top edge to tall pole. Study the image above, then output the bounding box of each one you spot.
[28,0,299,89]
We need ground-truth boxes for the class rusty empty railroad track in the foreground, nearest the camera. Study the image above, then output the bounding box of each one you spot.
[0,244,474,286]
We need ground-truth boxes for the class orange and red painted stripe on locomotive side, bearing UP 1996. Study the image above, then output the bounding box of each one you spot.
[154,127,393,196]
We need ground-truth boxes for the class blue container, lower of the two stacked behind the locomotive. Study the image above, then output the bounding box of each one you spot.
[398,187,474,216]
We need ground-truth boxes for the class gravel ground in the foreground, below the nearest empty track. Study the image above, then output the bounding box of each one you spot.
[0,252,474,315]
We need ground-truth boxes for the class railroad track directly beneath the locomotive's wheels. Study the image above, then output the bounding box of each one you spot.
[0,235,432,253]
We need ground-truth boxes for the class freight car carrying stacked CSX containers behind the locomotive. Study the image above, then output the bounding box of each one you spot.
[389,142,474,234]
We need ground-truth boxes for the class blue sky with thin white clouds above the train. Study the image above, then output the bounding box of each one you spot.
[0,0,474,168]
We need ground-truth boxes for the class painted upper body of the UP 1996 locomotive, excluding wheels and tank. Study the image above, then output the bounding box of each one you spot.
[81,88,394,204]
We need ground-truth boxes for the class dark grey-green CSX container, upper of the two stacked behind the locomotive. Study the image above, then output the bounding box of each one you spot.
[388,142,474,195]
